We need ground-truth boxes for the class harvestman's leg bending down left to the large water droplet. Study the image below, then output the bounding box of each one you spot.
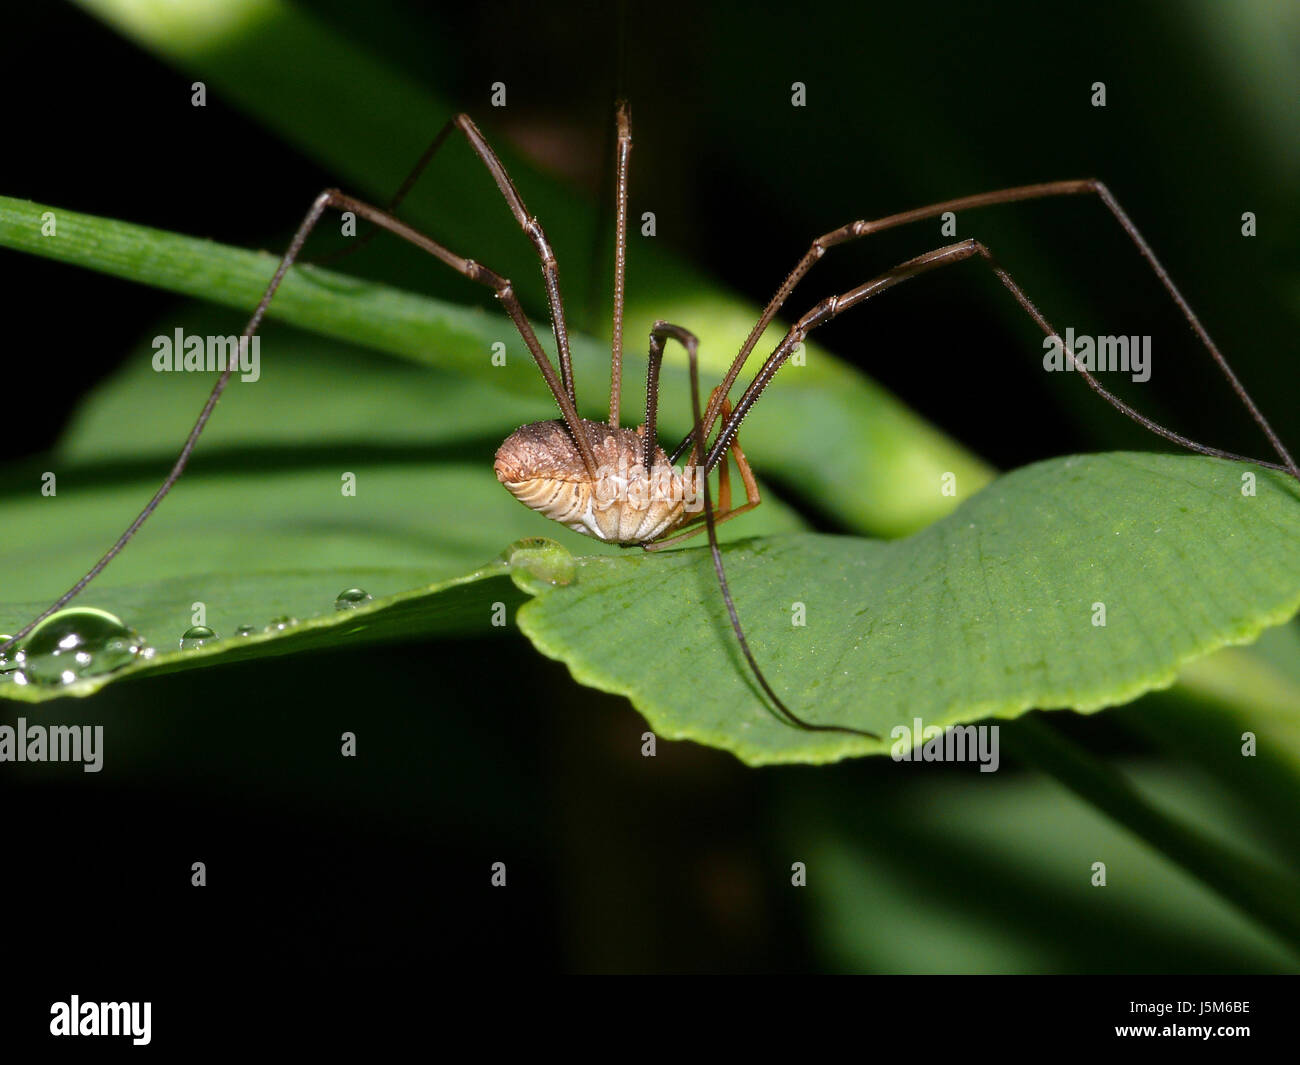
[0,189,597,651]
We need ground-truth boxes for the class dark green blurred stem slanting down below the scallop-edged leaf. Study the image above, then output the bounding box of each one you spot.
[1002,718,1300,954]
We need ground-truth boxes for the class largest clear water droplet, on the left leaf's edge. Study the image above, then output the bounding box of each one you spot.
[13,607,147,687]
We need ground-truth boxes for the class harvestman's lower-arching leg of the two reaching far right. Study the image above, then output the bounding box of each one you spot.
[705,241,1300,477]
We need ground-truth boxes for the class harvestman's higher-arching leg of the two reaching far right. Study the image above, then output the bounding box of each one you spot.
[672,178,1300,479]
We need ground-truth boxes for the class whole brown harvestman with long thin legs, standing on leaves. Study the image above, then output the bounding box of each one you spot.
[0,103,1300,739]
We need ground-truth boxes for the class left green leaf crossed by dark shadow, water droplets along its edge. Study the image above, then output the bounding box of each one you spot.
[0,309,802,701]
